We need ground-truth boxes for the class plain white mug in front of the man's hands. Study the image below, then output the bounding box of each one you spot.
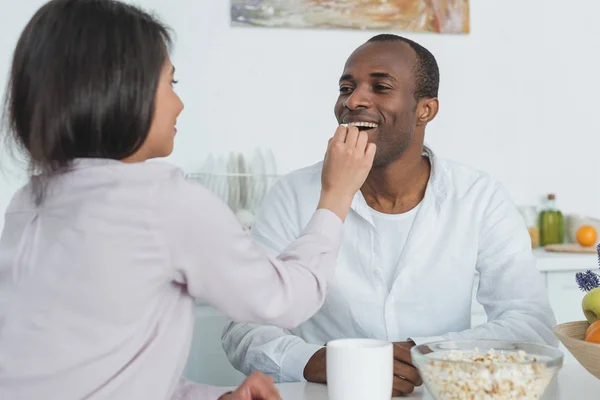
[326,339,394,400]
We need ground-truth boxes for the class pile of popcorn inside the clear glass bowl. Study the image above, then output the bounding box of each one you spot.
[422,349,553,400]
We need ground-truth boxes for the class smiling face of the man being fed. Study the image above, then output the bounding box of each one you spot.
[334,42,417,167]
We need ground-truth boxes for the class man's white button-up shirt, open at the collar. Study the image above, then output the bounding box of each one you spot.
[223,149,557,382]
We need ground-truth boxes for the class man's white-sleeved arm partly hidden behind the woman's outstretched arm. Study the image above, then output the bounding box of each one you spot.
[221,176,322,382]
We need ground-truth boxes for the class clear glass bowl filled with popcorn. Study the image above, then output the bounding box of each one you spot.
[411,340,563,400]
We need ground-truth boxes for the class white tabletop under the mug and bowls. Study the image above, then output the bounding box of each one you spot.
[270,364,600,400]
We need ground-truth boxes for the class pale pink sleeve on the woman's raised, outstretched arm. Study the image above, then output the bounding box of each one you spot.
[158,174,343,328]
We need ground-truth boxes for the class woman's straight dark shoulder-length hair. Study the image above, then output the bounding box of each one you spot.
[5,0,171,173]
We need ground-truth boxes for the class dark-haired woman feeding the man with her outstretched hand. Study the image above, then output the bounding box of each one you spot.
[0,0,375,400]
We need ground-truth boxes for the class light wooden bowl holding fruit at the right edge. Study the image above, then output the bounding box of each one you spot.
[554,321,600,379]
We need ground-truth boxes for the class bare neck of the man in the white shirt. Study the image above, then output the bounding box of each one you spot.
[361,145,431,214]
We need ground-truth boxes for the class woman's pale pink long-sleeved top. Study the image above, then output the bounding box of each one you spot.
[0,160,342,400]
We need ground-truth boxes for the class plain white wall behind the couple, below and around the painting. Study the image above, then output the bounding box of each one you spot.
[0,0,600,231]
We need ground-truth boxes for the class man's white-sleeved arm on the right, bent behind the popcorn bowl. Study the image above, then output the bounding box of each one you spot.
[411,185,558,346]
